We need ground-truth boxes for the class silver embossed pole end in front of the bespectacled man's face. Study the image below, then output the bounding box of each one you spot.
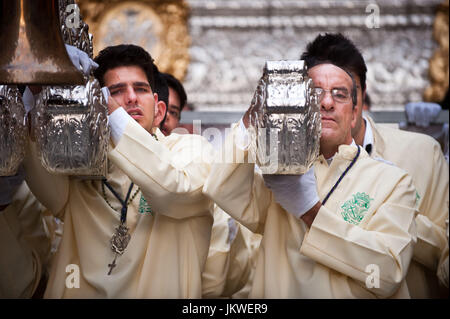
[250,60,321,174]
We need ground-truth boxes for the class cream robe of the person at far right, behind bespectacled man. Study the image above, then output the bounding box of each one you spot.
[368,118,449,298]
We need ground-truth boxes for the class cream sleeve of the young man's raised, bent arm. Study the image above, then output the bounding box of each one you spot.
[109,120,214,219]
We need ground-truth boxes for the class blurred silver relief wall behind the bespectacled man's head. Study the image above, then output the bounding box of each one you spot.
[184,0,442,111]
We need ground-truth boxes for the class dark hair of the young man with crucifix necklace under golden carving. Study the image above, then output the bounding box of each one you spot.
[94,44,155,91]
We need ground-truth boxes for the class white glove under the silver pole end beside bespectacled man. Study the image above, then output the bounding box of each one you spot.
[263,166,319,218]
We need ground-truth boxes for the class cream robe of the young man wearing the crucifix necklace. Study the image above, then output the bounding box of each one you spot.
[25,120,213,298]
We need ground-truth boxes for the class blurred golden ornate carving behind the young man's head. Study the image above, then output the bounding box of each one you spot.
[77,0,190,79]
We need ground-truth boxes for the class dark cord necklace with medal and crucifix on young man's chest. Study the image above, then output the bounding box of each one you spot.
[102,179,139,275]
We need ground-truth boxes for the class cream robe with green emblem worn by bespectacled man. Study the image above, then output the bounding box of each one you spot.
[203,126,417,298]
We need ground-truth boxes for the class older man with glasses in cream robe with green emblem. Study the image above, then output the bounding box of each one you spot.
[203,43,417,298]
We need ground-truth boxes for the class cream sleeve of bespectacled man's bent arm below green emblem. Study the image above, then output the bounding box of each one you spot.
[300,174,417,298]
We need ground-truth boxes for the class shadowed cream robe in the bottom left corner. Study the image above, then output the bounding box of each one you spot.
[0,182,50,298]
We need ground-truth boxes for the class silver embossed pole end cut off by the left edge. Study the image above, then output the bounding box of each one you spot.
[0,85,28,176]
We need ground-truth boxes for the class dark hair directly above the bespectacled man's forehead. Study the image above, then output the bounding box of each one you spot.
[301,33,367,104]
